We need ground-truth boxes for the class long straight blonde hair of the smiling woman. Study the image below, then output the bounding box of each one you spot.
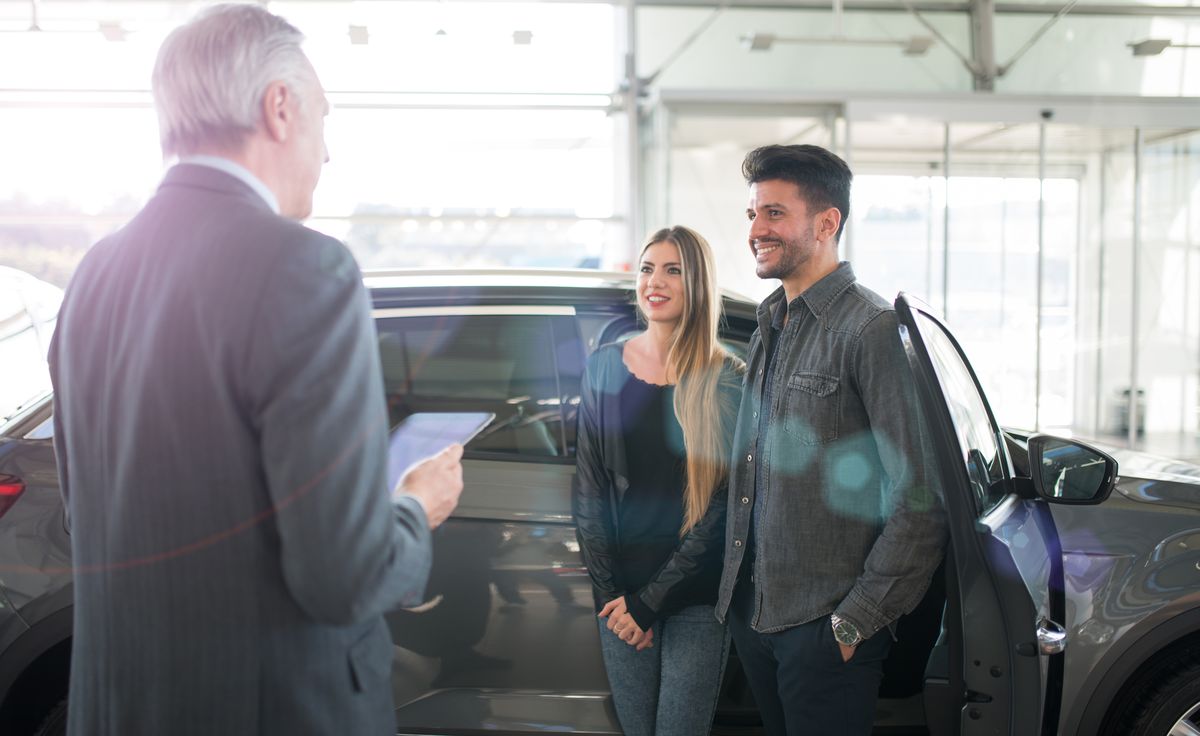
[642,225,740,537]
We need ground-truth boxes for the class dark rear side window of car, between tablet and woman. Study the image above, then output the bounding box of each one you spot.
[377,315,582,459]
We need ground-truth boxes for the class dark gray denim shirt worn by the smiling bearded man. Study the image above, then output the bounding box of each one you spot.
[716,263,947,636]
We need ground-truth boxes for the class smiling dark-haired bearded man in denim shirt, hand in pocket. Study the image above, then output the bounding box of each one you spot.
[716,145,946,736]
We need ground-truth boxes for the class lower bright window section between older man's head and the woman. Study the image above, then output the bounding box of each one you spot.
[310,106,628,269]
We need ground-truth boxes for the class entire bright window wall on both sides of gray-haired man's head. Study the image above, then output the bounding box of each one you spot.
[0,0,630,278]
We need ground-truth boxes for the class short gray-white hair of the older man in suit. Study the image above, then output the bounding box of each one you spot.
[151,5,311,156]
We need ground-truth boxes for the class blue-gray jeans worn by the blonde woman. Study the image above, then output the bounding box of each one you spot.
[599,605,730,736]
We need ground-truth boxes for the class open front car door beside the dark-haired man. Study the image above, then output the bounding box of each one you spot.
[895,293,1067,736]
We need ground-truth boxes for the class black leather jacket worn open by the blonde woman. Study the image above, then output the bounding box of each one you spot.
[571,343,745,629]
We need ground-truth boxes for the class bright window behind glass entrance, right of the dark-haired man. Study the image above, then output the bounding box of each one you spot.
[851,168,1079,427]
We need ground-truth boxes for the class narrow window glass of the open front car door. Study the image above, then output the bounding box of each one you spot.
[917,312,1006,514]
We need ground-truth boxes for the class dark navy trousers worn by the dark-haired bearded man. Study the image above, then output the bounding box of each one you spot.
[730,580,892,736]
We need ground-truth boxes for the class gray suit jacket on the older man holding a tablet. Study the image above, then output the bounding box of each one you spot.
[50,164,431,736]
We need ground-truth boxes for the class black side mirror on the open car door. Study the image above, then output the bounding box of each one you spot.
[1028,435,1117,504]
